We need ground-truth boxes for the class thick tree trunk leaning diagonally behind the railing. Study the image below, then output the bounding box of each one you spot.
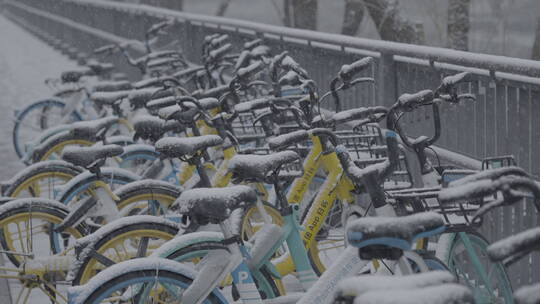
[364,0,424,43]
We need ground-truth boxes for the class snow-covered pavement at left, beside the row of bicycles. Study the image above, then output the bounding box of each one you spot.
[0,15,76,180]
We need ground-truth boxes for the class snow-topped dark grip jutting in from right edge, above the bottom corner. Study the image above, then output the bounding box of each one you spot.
[487,227,540,262]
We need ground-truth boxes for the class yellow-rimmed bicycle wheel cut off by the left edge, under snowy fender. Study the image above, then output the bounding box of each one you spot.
[0,198,87,267]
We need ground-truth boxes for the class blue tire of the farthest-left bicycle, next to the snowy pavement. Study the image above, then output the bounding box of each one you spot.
[12,99,82,158]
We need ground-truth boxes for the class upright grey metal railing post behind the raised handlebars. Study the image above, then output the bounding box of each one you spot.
[375,53,398,106]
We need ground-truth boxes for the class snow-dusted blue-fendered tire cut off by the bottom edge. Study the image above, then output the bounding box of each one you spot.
[77,264,227,304]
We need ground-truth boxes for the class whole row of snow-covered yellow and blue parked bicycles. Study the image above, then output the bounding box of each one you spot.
[0,21,540,303]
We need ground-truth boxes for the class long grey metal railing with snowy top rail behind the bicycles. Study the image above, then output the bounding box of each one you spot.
[5,0,540,286]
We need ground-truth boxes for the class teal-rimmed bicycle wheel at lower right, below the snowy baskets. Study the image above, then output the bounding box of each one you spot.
[445,232,513,303]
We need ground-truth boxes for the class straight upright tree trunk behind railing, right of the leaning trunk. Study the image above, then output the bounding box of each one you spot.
[447,0,471,51]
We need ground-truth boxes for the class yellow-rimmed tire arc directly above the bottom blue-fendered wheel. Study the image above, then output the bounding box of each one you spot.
[72,219,179,286]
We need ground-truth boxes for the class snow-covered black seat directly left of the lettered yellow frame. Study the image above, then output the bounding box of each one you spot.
[229,151,300,182]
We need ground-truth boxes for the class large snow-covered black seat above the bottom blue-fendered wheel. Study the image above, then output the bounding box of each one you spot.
[173,185,257,225]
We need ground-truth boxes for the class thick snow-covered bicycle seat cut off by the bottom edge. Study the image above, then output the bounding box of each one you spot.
[354,283,475,304]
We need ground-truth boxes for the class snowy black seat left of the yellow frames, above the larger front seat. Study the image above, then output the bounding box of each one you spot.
[155,135,223,158]
